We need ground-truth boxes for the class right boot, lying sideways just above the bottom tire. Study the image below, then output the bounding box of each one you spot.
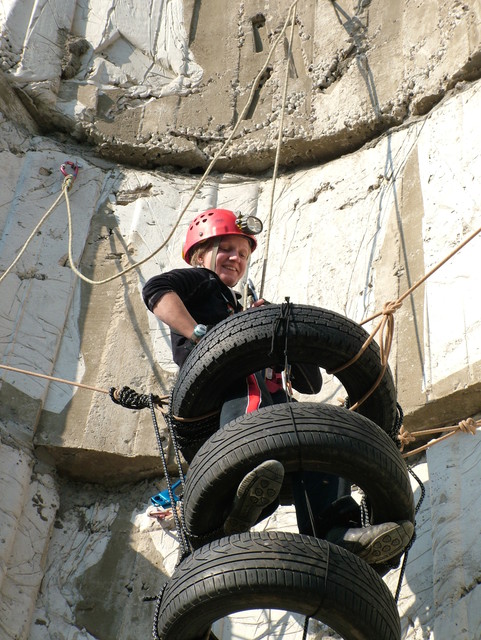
[326,520,414,564]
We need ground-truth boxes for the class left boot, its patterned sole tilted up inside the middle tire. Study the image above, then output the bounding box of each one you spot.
[224,460,284,535]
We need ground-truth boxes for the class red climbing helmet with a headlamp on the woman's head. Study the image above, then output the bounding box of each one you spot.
[182,209,262,264]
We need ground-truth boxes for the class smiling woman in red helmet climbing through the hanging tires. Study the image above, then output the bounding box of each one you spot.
[143,209,413,563]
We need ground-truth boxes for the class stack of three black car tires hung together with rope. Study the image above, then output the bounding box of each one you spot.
[158,305,414,640]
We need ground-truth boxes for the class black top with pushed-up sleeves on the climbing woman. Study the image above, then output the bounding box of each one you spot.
[142,267,242,367]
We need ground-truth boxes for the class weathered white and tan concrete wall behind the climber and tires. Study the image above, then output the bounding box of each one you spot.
[0,0,481,640]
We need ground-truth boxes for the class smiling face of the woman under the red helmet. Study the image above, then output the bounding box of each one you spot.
[202,235,251,287]
